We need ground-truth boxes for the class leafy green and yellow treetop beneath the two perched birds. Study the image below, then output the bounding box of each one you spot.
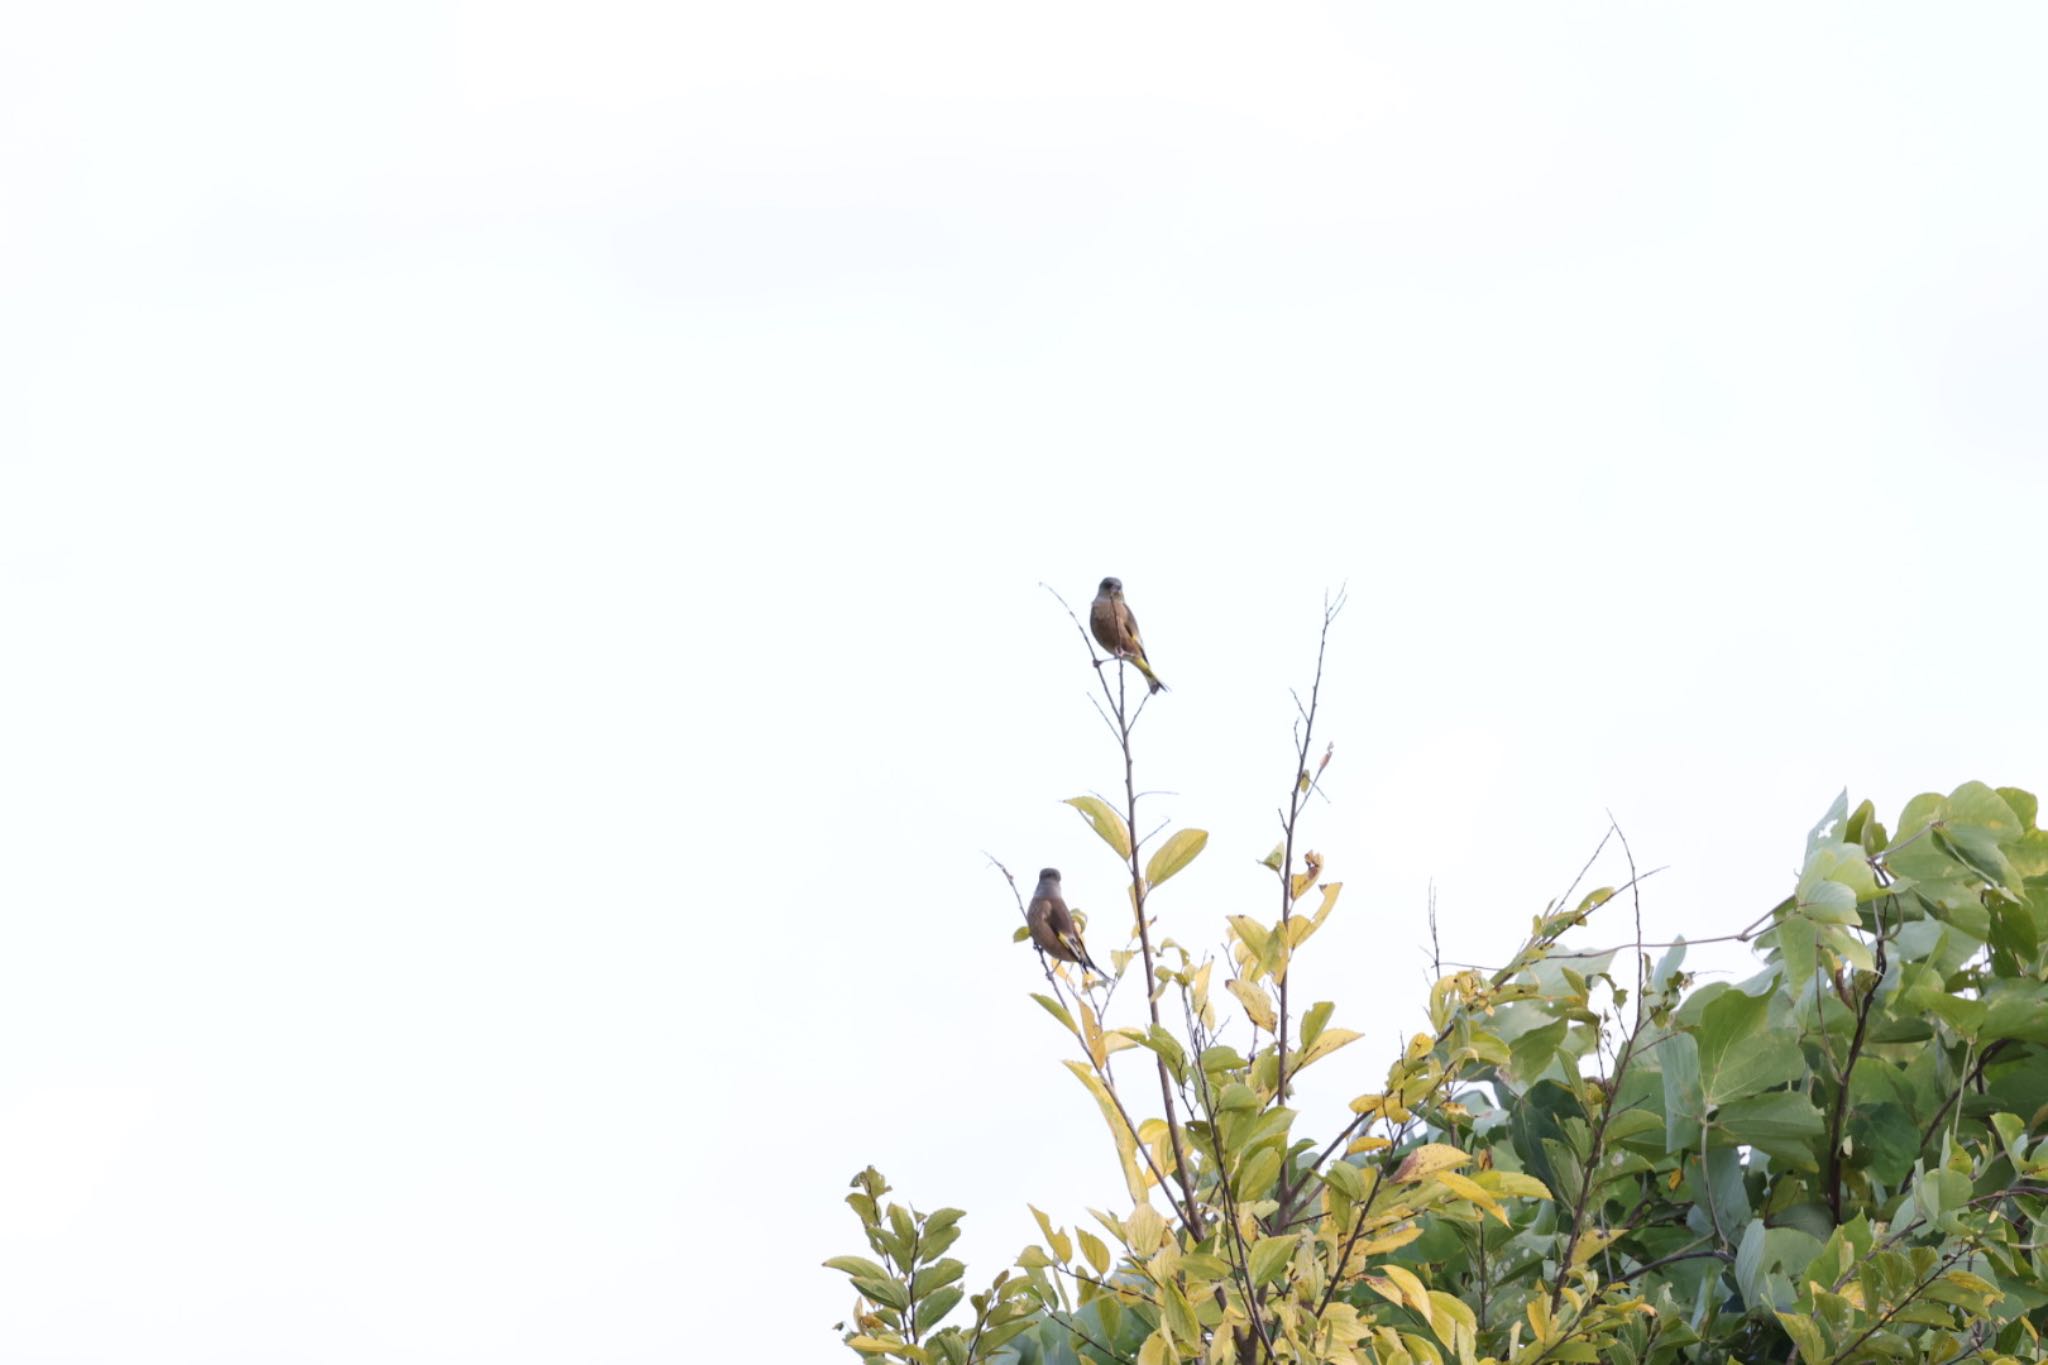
[825,598,2048,1365]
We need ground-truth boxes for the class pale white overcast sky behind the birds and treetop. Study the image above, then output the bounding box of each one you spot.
[0,2,2048,1365]
